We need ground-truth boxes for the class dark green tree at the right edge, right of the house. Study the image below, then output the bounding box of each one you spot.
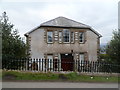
[106,30,120,64]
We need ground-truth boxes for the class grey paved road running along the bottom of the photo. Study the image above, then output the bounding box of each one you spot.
[2,82,118,88]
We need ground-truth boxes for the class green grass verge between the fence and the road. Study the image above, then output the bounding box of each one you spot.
[2,71,118,82]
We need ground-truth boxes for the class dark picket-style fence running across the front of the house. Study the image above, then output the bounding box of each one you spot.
[2,59,120,73]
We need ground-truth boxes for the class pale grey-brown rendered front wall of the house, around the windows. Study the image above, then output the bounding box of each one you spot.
[30,28,98,60]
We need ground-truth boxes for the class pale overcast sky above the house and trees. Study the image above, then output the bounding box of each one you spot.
[0,0,119,43]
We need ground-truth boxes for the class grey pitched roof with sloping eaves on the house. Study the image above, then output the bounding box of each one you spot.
[25,17,102,37]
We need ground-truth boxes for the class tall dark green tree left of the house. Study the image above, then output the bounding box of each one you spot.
[0,12,27,66]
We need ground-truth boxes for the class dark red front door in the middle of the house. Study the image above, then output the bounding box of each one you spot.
[61,54,74,71]
